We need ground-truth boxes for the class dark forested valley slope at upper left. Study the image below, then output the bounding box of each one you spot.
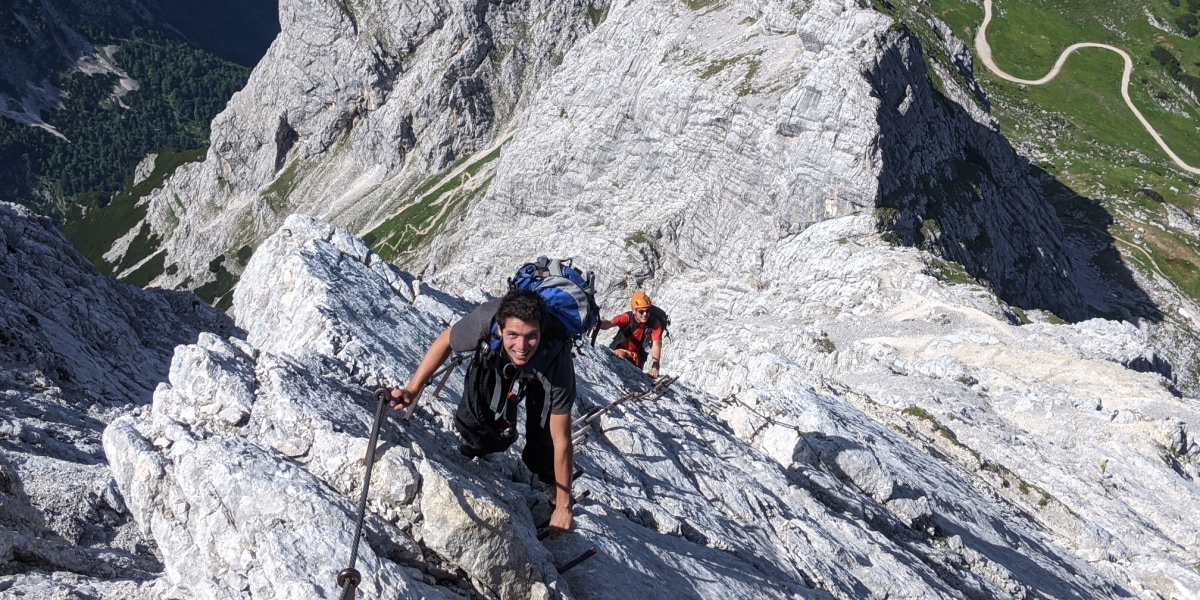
[0,32,250,223]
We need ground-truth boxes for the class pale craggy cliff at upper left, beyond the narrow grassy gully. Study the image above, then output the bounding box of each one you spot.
[126,0,595,300]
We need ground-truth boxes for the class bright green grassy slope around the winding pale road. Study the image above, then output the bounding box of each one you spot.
[907,0,1200,304]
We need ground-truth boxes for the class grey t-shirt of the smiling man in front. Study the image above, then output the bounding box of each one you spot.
[450,298,575,414]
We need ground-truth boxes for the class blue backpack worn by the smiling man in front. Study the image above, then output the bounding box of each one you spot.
[509,257,600,338]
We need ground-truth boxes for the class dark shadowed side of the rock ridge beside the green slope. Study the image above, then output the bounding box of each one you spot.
[864,29,1163,323]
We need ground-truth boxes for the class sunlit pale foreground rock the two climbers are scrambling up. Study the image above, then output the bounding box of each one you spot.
[0,208,1200,599]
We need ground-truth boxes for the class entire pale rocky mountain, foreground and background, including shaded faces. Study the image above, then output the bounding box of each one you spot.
[7,0,1200,600]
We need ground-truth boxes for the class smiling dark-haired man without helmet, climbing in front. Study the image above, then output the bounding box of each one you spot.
[391,289,575,535]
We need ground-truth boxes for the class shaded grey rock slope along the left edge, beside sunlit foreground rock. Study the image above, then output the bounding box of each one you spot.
[0,203,234,598]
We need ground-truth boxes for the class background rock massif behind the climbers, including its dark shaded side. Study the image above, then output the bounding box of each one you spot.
[126,0,1086,318]
